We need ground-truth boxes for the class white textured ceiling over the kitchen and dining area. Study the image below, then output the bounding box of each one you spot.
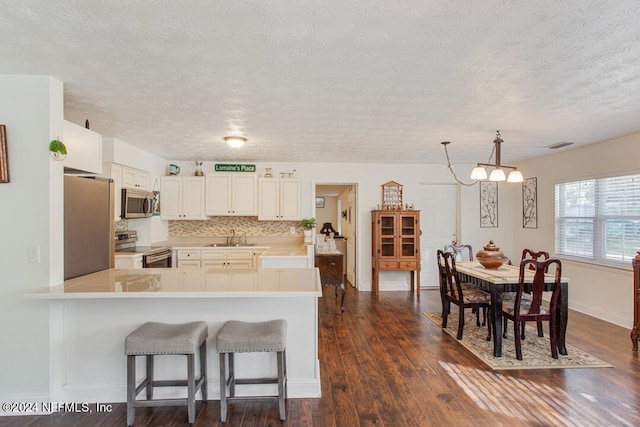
[0,0,640,164]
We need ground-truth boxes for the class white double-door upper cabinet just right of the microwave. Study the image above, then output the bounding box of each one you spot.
[160,176,207,220]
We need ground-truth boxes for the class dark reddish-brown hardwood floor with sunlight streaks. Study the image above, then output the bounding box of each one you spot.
[0,286,640,427]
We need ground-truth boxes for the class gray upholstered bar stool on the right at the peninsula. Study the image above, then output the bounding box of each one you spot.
[216,319,287,422]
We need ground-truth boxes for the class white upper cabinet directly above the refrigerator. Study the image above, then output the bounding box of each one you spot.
[62,120,102,174]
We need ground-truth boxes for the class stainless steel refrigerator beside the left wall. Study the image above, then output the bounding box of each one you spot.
[64,175,114,280]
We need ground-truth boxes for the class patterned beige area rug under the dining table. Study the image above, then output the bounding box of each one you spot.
[424,311,613,370]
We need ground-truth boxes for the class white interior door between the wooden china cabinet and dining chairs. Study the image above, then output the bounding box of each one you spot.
[420,184,458,288]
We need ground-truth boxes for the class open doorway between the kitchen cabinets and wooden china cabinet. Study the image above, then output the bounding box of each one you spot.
[315,183,358,288]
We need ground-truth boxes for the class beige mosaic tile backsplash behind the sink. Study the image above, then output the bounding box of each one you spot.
[169,216,304,237]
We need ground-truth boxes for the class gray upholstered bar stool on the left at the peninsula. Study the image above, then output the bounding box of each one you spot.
[124,322,208,426]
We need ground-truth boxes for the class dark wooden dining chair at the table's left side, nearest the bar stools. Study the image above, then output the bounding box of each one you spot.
[437,249,492,341]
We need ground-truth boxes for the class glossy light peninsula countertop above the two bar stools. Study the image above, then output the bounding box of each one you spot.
[25,268,322,299]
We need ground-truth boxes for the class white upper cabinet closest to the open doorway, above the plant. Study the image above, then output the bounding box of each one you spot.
[258,178,300,221]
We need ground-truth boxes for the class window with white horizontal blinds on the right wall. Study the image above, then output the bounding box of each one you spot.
[555,175,640,265]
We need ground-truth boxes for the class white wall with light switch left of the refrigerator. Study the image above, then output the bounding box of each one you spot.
[0,75,63,401]
